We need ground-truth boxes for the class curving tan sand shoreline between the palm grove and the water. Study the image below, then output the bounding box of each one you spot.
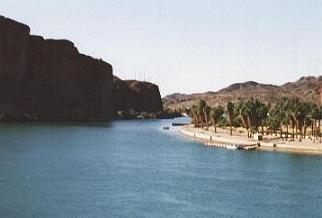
[178,125,322,155]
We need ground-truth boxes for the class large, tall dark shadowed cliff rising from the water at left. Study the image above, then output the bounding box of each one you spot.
[0,16,113,121]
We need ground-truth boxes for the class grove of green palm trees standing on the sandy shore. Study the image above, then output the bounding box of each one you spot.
[187,97,322,141]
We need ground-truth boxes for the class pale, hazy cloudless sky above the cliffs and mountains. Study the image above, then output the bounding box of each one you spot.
[0,0,322,96]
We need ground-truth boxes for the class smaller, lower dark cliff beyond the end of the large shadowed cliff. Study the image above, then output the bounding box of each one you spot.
[113,77,162,113]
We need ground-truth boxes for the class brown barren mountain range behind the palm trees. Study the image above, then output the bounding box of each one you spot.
[162,76,322,109]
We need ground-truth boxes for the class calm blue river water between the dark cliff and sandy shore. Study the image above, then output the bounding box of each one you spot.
[0,120,322,218]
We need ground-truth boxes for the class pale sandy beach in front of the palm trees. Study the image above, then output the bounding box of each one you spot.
[179,125,322,155]
